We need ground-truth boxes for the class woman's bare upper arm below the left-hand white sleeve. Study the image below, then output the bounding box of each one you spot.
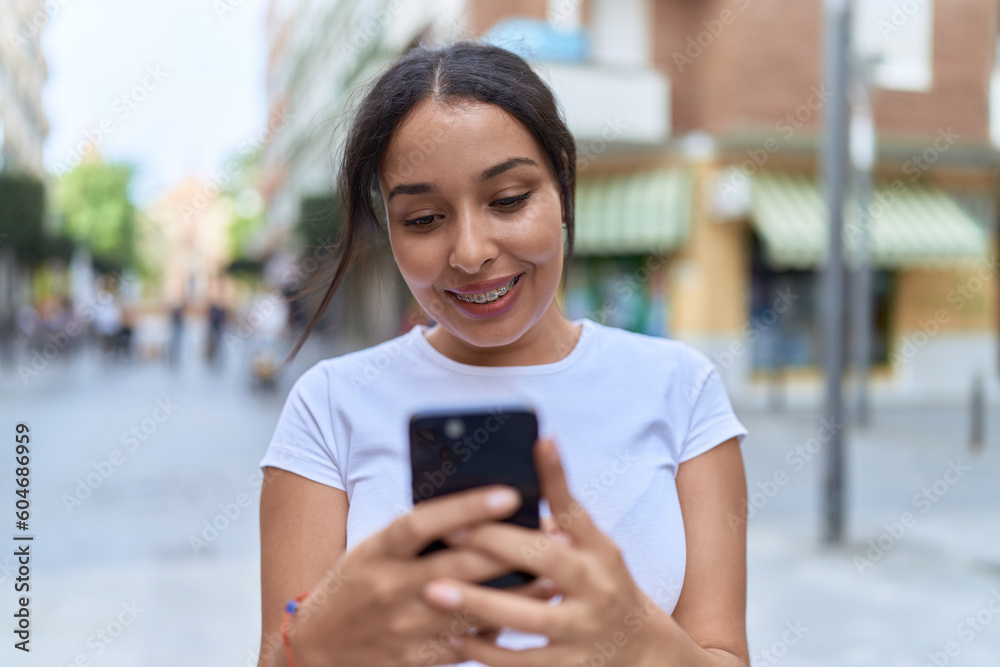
[257,466,348,667]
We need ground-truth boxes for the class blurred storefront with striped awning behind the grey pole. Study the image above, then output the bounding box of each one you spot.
[748,172,995,400]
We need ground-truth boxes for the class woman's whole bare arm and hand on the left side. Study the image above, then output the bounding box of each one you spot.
[258,467,552,667]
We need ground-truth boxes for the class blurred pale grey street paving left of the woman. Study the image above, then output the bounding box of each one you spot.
[0,320,340,667]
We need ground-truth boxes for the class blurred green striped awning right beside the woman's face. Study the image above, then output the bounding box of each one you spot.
[573,168,694,255]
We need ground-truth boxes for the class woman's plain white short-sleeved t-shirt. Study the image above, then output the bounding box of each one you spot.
[260,318,747,666]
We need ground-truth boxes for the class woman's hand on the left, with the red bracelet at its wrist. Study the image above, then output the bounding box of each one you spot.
[291,486,552,667]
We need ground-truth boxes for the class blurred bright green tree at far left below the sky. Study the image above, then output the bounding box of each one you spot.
[53,161,137,270]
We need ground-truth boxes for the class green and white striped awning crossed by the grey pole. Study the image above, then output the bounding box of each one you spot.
[751,173,987,268]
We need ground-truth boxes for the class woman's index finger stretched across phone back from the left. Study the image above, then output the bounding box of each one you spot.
[376,485,521,558]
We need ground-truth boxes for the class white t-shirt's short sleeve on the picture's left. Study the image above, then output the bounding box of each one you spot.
[260,361,347,491]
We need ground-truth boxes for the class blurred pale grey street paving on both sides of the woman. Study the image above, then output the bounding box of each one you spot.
[0,322,1000,667]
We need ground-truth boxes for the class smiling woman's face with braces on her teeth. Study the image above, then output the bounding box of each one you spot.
[379,100,563,354]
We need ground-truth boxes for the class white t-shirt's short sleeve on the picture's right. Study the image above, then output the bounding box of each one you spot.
[678,354,747,463]
